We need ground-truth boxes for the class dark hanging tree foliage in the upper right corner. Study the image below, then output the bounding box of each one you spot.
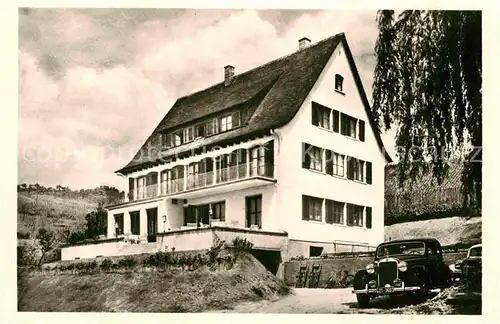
[372,10,482,210]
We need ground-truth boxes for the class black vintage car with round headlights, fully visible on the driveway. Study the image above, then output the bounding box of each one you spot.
[353,238,451,308]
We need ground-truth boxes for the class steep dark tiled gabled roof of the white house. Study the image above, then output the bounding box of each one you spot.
[117,33,392,173]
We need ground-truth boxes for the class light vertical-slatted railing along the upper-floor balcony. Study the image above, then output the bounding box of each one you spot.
[129,164,274,201]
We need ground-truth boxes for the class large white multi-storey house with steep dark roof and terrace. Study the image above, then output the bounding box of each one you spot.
[62,33,391,260]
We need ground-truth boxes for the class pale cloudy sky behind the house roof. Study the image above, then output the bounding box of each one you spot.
[18,9,394,189]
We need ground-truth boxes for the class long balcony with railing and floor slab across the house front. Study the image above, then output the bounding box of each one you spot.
[124,163,274,201]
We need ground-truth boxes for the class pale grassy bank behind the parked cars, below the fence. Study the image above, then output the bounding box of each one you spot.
[385,217,482,245]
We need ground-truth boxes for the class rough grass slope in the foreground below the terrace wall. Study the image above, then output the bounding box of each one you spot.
[18,254,289,312]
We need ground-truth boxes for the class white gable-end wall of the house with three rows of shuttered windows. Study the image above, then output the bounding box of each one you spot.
[276,41,385,245]
